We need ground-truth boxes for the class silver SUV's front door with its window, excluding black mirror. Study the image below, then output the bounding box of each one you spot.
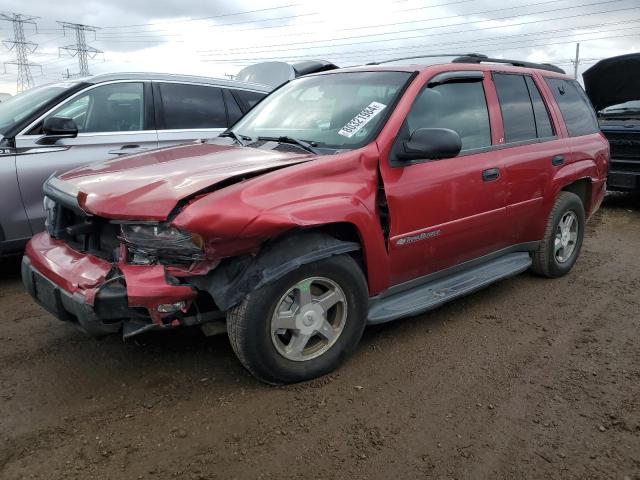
[16,82,158,233]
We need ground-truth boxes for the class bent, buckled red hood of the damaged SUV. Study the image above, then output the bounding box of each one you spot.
[56,143,315,220]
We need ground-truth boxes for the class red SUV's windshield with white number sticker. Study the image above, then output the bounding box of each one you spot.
[231,72,411,149]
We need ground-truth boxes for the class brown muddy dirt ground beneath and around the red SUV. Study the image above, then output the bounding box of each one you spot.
[0,195,640,480]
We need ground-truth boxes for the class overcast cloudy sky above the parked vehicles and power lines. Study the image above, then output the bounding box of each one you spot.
[0,0,640,94]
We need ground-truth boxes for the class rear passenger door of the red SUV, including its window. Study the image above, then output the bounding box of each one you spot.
[492,72,571,244]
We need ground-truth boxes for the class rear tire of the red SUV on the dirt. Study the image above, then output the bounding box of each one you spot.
[531,192,585,278]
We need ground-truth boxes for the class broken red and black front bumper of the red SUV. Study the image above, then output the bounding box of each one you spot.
[22,233,196,338]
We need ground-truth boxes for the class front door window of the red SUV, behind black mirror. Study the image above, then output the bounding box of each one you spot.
[407,82,491,151]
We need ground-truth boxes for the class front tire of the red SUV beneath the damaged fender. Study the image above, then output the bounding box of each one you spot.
[227,255,368,385]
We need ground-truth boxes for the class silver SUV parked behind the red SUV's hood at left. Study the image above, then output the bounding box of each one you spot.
[0,73,270,255]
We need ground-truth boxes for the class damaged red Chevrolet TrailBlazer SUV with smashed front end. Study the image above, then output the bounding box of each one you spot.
[22,56,609,383]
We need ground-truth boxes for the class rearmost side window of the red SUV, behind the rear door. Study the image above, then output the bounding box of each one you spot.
[545,78,599,137]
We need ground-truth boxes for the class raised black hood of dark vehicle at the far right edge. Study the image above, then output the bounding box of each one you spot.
[582,53,640,111]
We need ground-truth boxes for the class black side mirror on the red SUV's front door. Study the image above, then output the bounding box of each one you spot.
[398,128,462,160]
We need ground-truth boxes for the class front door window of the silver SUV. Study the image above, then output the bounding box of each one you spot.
[49,82,145,133]
